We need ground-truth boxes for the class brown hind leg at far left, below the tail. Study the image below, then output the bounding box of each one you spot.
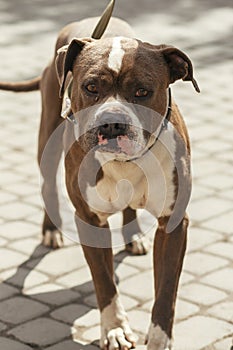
[38,63,63,248]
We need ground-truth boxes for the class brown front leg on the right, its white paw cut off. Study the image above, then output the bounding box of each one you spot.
[147,217,188,350]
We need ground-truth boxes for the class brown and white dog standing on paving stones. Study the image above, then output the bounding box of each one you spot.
[0,10,199,350]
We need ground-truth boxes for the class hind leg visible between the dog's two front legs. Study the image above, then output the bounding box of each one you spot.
[122,207,151,255]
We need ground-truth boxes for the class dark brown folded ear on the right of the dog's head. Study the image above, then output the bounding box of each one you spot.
[161,46,200,92]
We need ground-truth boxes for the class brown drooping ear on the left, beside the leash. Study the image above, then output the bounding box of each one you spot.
[55,38,91,97]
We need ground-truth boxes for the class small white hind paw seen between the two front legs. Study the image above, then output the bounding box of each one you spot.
[125,233,151,255]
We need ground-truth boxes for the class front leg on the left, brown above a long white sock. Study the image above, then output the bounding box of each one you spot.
[77,218,136,350]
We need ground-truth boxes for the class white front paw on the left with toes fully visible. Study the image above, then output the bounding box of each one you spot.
[100,327,137,350]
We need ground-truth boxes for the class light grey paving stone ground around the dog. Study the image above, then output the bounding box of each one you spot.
[0,0,233,350]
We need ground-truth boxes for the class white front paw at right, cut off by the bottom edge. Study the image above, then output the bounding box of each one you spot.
[146,324,172,350]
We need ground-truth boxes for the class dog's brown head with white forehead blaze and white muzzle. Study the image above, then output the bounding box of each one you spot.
[56,37,198,159]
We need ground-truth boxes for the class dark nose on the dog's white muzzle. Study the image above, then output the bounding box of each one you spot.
[98,112,128,139]
